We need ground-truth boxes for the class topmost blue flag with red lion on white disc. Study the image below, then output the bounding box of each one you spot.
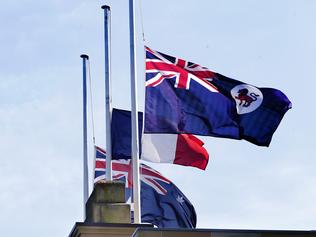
[144,47,291,146]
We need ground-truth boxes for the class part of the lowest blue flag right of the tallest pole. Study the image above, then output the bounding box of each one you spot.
[132,164,196,228]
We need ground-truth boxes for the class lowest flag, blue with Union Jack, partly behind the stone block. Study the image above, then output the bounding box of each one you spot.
[94,147,196,228]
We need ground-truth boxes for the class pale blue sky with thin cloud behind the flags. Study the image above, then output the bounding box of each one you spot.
[0,0,316,237]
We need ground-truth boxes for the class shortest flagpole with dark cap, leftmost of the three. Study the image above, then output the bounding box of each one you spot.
[80,54,89,217]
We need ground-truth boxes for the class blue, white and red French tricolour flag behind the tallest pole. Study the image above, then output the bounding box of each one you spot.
[111,109,209,170]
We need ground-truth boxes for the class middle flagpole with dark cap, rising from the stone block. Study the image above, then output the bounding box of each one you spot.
[101,5,112,180]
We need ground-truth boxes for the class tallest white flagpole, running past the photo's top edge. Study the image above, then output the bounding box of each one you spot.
[129,0,141,224]
